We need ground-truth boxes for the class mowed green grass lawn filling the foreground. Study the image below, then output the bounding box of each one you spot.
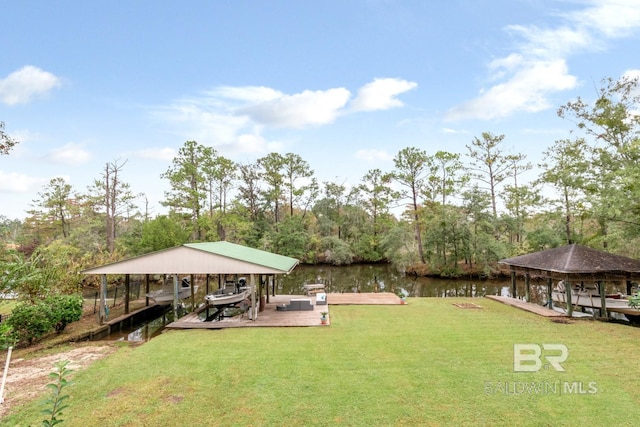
[0,298,640,427]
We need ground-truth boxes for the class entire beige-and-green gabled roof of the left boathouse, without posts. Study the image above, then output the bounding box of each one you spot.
[81,242,299,274]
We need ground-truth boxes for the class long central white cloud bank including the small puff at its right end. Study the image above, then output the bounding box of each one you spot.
[152,79,416,155]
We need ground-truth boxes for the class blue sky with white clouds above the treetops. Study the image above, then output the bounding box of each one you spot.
[0,0,640,219]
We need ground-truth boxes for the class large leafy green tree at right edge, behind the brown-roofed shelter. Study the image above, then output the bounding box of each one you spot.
[558,76,640,248]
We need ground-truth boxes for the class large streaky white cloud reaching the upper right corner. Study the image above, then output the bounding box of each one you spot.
[445,0,640,120]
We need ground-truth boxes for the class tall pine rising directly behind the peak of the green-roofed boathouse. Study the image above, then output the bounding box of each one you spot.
[160,141,214,240]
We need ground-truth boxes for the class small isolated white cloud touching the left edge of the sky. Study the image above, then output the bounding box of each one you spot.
[0,65,61,105]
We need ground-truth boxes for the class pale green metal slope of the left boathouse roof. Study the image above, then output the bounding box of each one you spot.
[183,242,299,273]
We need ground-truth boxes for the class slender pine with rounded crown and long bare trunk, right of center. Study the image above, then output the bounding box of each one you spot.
[393,147,432,264]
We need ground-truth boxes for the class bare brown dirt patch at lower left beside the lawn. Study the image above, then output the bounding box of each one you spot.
[0,344,116,418]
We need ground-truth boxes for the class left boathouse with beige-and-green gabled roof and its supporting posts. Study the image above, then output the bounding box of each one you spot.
[81,241,299,325]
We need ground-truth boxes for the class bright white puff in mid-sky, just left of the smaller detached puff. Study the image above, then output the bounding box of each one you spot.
[238,88,351,128]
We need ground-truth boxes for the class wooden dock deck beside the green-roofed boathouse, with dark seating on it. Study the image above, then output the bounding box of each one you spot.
[166,292,401,329]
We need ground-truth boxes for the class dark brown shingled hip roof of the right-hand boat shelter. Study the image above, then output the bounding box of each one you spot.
[499,244,640,280]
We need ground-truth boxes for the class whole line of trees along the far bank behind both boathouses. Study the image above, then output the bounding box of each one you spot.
[0,74,640,283]
